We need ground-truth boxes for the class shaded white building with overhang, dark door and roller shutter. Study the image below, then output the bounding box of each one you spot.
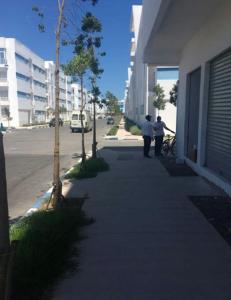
[143,0,231,195]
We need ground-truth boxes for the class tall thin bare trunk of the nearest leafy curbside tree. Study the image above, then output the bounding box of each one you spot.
[52,0,65,207]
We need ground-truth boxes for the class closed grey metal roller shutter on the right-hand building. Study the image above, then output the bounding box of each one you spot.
[206,50,231,181]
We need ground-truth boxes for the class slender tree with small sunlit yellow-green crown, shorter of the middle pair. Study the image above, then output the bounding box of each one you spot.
[64,49,91,164]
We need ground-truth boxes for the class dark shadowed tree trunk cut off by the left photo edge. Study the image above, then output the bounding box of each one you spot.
[0,132,10,299]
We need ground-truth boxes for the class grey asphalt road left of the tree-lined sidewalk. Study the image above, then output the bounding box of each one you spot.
[4,120,109,219]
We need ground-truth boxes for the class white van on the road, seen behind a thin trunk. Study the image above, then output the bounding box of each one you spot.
[70,110,93,132]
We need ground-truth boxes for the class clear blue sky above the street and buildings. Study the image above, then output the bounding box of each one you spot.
[0,0,142,99]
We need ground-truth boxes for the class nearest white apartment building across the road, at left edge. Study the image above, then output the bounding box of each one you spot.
[0,37,47,127]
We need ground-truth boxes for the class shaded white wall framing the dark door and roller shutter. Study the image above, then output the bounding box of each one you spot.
[177,1,231,194]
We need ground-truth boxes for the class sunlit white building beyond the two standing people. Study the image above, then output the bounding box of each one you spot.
[125,5,178,130]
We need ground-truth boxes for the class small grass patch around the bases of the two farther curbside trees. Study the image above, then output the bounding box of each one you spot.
[65,157,109,179]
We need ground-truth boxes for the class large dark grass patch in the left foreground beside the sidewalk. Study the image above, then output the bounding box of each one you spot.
[10,207,92,300]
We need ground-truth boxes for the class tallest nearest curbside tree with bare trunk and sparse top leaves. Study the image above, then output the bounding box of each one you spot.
[32,0,98,207]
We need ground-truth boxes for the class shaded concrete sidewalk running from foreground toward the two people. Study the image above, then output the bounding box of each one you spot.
[53,141,231,300]
